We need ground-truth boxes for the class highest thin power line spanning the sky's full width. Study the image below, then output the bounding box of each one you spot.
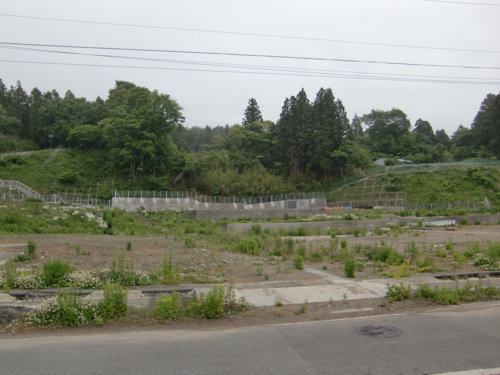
[0,12,500,53]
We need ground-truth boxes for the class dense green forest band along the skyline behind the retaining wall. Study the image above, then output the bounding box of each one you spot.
[0,80,500,196]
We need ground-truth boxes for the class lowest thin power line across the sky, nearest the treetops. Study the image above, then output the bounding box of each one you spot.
[0,59,499,85]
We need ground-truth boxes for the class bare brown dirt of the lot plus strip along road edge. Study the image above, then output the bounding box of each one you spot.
[0,225,500,334]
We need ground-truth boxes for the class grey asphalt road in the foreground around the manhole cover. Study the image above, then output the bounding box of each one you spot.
[0,303,500,375]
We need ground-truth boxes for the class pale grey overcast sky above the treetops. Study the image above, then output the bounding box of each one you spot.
[0,0,500,135]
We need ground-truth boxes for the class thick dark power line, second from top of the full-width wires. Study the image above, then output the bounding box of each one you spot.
[0,41,500,70]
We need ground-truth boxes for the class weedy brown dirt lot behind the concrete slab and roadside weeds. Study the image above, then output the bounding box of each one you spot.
[0,225,500,284]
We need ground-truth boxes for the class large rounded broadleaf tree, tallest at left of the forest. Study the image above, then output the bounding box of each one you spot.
[99,81,184,181]
